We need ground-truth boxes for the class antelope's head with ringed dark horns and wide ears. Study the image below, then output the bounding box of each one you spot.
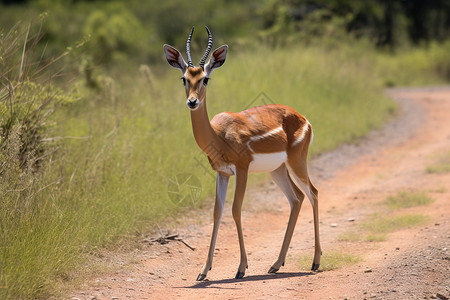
[164,26,228,110]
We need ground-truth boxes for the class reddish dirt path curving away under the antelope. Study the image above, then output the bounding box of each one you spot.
[68,88,450,299]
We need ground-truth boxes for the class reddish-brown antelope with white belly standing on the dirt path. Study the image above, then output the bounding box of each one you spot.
[164,26,322,281]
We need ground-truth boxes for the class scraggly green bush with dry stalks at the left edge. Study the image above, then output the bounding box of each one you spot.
[0,20,76,171]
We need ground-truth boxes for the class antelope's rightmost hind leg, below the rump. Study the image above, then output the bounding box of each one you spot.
[287,162,322,271]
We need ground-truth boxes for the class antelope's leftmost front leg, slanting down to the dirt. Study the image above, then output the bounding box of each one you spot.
[197,173,230,281]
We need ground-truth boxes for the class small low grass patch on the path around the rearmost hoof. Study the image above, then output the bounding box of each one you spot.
[298,251,361,271]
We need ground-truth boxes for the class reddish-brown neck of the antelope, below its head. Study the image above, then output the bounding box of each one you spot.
[191,100,223,157]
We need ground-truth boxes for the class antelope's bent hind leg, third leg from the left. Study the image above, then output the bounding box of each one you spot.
[269,164,305,273]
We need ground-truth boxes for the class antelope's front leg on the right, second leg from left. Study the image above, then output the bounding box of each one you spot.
[233,169,248,279]
